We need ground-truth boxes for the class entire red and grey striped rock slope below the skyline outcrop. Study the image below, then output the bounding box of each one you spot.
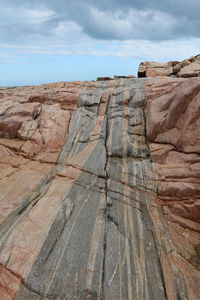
[0,78,200,300]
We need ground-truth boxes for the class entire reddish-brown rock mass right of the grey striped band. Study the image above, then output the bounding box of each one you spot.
[145,78,200,299]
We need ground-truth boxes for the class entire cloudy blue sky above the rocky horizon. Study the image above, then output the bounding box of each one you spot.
[0,0,200,86]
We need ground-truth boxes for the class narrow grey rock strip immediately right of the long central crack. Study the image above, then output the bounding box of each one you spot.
[103,80,127,299]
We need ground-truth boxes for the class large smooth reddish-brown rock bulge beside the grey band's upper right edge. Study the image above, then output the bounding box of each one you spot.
[147,79,200,153]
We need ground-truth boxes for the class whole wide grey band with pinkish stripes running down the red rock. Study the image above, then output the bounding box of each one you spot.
[12,79,191,300]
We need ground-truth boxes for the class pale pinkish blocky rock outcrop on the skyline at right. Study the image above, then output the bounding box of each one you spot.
[138,55,200,78]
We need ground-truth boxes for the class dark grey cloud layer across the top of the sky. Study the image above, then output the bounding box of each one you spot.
[0,0,200,42]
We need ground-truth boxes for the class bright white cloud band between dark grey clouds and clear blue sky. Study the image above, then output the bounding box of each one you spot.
[0,37,200,61]
